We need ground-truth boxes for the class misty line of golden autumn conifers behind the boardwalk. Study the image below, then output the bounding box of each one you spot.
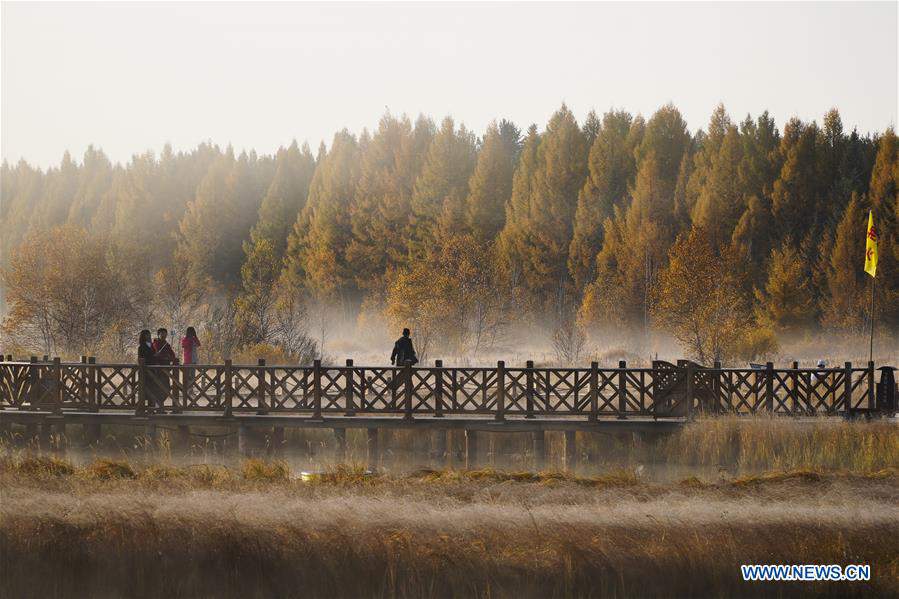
[0,105,899,362]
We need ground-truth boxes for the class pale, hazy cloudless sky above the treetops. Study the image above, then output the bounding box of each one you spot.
[0,2,899,167]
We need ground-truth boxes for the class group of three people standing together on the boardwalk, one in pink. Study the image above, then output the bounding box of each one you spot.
[137,327,200,413]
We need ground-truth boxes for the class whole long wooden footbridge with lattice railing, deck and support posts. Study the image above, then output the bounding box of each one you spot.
[0,356,896,468]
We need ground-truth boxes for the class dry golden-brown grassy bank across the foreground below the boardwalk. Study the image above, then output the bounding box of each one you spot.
[0,457,899,597]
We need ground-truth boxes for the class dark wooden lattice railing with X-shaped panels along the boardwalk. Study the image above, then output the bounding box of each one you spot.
[0,356,876,420]
